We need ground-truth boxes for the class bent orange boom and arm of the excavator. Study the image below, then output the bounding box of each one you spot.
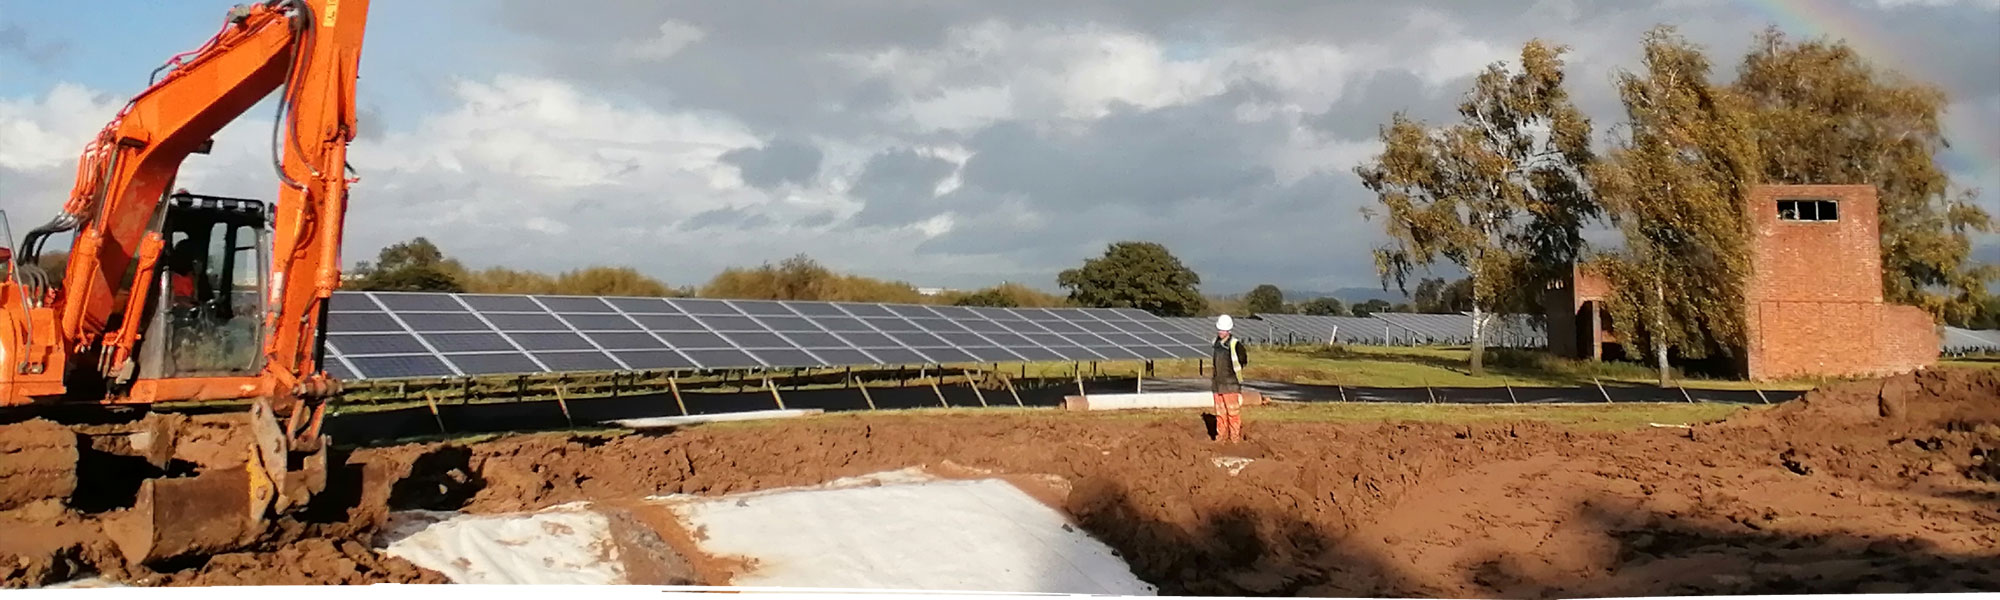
[24,0,368,400]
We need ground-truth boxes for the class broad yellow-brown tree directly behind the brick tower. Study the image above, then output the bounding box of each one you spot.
[1734,28,2000,320]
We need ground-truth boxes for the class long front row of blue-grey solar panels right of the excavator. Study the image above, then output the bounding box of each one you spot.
[326,292,1202,378]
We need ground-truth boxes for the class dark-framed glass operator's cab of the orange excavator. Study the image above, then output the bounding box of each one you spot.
[140,194,270,378]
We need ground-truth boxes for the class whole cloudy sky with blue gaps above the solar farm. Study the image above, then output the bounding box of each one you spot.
[0,0,2000,292]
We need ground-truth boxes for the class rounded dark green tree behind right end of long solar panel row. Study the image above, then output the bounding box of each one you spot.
[1056,242,1202,316]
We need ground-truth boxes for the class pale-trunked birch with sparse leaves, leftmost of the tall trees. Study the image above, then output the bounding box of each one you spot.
[1356,40,1600,374]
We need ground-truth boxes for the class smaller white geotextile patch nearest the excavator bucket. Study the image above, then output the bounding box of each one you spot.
[382,502,626,586]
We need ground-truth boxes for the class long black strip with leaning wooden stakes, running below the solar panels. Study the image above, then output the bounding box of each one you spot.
[324,378,1802,446]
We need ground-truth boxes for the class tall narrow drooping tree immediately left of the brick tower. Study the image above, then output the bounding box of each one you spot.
[1592,26,1760,386]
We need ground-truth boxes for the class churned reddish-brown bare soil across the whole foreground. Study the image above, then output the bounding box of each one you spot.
[0,370,2000,598]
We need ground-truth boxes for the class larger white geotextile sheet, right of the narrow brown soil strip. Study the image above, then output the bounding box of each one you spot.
[654,470,1158,596]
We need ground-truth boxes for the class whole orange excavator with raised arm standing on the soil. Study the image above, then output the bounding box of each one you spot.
[0,0,368,564]
